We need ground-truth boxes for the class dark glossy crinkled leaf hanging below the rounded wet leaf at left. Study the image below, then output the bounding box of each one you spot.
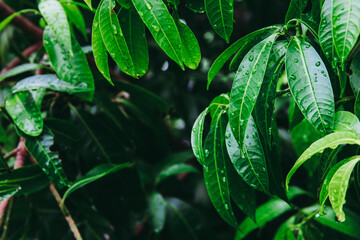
[23,127,69,188]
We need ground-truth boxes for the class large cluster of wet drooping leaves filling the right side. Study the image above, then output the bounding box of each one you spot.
[191,0,360,239]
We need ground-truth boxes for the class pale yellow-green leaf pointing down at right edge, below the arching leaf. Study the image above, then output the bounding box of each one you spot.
[329,156,360,222]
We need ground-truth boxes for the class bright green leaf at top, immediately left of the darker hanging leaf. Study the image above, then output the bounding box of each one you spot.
[99,0,139,78]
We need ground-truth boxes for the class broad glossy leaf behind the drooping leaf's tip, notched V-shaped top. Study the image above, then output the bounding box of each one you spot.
[225,117,269,193]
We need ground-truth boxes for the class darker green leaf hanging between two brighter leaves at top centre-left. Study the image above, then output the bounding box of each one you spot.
[119,8,149,78]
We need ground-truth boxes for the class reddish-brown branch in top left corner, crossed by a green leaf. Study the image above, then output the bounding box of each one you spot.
[0,0,43,41]
